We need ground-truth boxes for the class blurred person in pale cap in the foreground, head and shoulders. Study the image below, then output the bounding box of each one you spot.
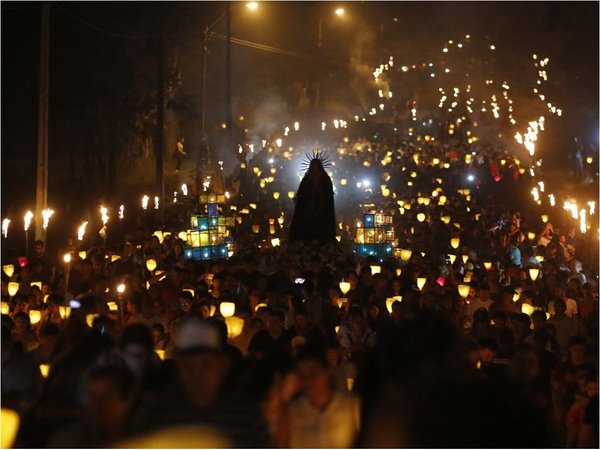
[133,317,272,448]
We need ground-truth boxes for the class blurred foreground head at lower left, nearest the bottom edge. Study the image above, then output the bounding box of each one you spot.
[87,363,136,431]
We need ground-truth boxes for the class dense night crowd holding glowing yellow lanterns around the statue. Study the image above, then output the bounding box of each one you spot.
[2,129,599,448]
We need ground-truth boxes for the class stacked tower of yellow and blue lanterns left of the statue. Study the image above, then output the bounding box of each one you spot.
[184,194,235,260]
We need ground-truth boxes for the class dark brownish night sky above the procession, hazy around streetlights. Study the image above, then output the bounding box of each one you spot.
[2,2,599,221]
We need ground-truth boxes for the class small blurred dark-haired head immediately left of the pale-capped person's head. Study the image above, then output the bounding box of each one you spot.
[119,323,154,380]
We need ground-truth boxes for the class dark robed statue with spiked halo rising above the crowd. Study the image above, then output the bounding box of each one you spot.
[290,152,336,244]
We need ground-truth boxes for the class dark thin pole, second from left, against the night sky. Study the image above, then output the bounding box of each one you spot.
[155,4,165,225]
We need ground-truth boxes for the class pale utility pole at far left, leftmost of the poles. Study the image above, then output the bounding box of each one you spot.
[35,3,50,243]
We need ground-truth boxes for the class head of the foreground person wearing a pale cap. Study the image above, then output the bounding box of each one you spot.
[173,317,227,407]
